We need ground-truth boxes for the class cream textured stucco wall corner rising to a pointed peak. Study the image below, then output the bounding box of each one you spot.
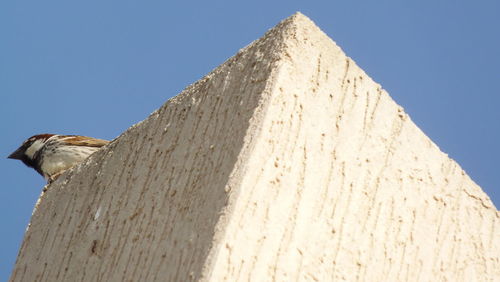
[11,14,500,281]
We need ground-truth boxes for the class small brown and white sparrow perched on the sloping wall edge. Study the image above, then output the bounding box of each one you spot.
[8,134,109,183]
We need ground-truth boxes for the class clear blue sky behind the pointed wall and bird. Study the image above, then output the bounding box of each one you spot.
[0,0,500,281]
